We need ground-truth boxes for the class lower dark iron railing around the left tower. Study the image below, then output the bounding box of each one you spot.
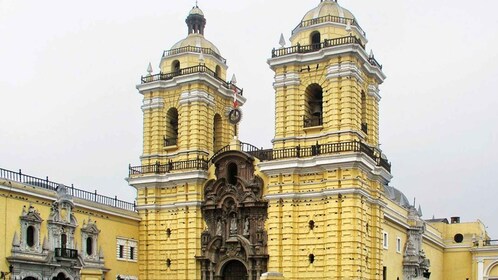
[129,159,208,176]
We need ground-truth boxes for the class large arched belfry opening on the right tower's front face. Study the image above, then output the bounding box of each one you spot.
[304,84,323,127]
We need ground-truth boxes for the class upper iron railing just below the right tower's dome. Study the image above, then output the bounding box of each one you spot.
[271,36,365,57]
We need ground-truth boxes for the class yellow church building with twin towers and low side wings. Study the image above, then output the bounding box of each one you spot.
[0,0,498,280]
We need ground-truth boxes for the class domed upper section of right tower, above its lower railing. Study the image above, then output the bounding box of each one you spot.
[268,0,385,148]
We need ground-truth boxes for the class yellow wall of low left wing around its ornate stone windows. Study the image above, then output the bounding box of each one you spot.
[0,179,139,280]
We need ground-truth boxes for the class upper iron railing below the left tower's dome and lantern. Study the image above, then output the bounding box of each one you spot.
[140,65,244,95]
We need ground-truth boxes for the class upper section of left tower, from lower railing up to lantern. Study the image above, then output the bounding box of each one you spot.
[137,6,245,166]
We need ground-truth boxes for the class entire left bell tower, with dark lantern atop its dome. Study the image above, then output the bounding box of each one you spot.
[128,6,245,280]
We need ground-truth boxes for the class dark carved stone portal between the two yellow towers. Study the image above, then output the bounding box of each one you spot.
[197,151,268,280]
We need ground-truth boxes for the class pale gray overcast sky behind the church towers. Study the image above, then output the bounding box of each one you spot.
[0,0,498,238]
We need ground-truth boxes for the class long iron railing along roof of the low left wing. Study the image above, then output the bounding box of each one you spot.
[0,168,135,211]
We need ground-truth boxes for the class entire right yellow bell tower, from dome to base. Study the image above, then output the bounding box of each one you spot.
[259,0,391,280]
